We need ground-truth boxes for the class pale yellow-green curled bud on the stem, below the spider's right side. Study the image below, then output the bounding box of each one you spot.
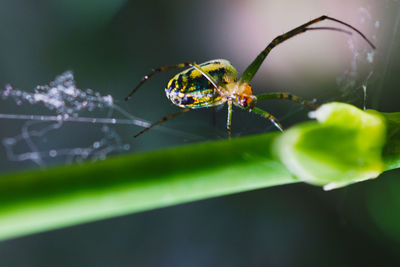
[274,102,386,190]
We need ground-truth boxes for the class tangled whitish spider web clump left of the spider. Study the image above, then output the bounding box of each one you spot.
[0,71,205,170]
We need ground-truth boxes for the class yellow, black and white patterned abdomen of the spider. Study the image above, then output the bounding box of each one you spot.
[165,59,237,109]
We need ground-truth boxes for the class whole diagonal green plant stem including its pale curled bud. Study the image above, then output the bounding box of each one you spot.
[0,103,400,240]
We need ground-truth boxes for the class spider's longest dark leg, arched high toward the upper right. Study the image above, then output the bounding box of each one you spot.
[239,16,375,83]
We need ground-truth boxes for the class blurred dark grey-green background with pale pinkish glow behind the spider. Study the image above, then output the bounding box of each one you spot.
[0,0,400,266]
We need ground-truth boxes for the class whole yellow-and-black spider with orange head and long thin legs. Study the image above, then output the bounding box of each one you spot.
[125,15,375,137]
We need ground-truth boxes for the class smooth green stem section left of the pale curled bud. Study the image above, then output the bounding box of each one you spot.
[0,134,298,242]
